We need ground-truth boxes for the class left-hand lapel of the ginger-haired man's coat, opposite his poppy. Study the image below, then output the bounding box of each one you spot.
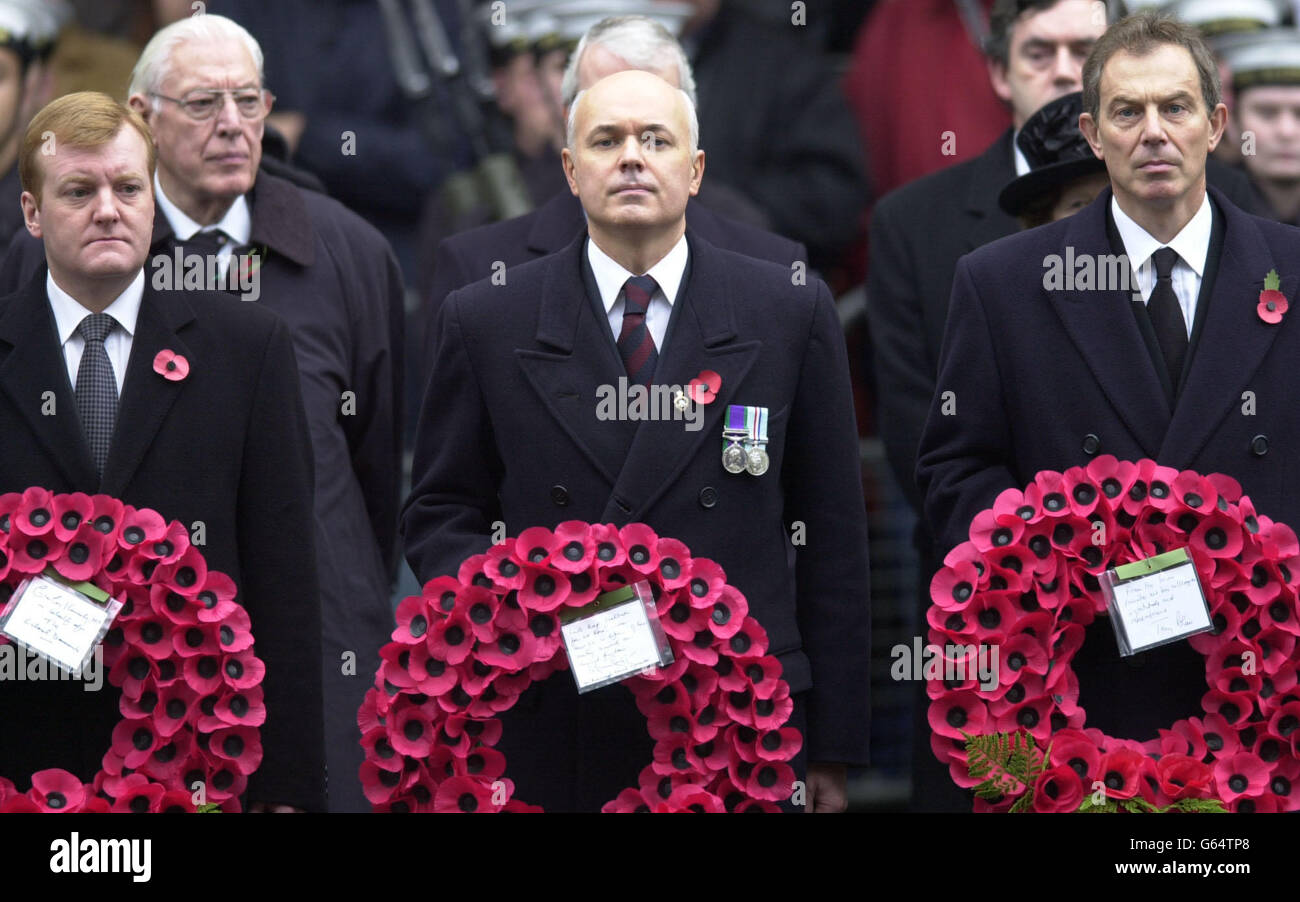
[0,265,99,491]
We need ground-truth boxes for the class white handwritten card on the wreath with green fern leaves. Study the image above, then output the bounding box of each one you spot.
[1112,561,1212,654]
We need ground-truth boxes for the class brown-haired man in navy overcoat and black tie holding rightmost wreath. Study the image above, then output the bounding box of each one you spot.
[918,13,1300,741]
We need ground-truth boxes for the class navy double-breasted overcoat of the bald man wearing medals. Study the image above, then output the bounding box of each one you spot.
[402,229,870,780]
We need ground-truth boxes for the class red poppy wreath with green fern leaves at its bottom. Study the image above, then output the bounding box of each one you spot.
[927,455,1300,812]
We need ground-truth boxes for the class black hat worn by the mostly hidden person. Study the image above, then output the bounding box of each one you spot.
[997,91,1106,216]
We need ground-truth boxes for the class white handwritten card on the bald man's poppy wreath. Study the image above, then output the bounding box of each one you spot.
[560,599,659,693]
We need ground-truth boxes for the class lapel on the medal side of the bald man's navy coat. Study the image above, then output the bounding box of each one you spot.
[602,230,763,522]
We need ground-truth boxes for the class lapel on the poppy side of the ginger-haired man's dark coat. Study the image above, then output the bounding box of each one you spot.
[100,279,193,496]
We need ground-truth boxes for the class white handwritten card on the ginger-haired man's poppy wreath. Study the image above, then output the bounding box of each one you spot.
[0,577,114,672]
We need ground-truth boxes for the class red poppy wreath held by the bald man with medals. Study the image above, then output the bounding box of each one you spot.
[358,520,803,812]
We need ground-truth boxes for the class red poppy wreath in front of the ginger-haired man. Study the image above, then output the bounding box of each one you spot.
[0,487,267,812]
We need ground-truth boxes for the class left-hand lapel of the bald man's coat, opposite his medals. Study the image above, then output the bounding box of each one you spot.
[515,230,636,485]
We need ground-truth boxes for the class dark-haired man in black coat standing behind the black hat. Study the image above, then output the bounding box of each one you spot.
[867,0,1106,810]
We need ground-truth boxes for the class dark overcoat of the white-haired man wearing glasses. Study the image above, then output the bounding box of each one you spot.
[0,172,404,811]
